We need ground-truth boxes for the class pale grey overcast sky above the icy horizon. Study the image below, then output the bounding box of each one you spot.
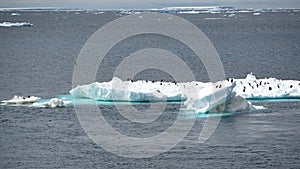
[0,0,300,9]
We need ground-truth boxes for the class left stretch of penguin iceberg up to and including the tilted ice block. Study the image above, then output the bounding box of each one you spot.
[70,77,255,113]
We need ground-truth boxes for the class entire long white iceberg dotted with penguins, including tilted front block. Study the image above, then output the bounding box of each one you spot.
[69,73,300,113]
